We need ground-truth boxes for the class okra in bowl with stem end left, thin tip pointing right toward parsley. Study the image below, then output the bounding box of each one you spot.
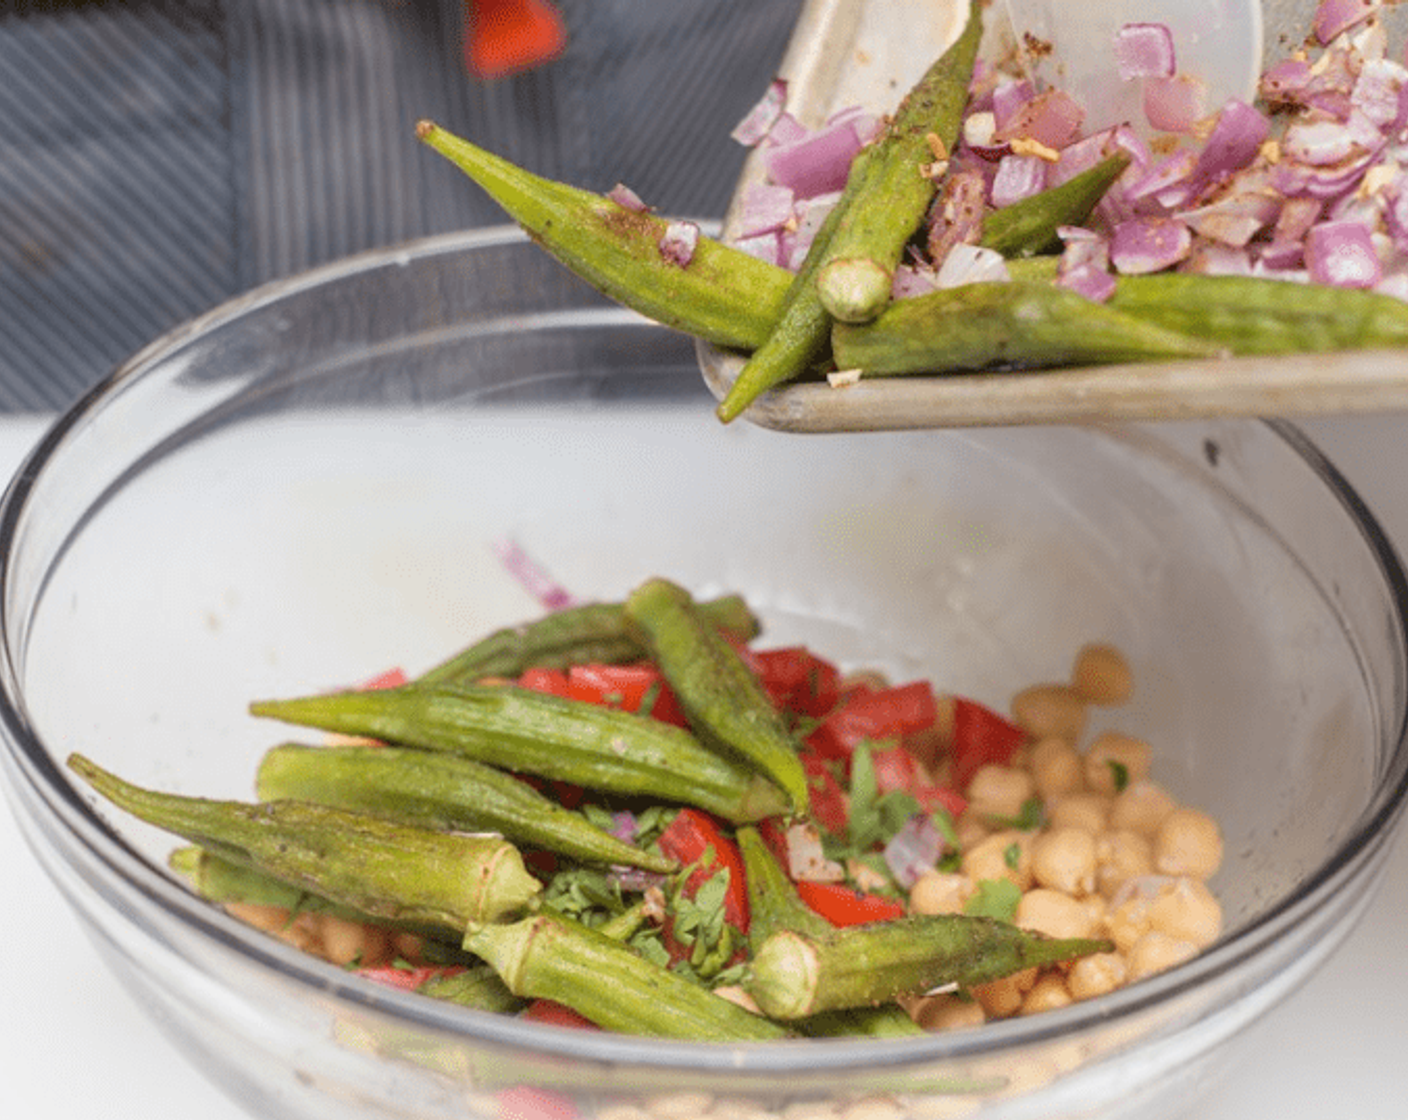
[255,742,674,872]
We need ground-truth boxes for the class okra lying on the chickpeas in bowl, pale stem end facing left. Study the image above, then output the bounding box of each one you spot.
[743,914,1112,1020]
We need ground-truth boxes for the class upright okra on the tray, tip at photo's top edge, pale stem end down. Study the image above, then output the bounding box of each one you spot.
[817,0,983,323]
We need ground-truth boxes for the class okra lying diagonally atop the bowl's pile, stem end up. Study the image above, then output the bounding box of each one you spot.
[625,578,810,814]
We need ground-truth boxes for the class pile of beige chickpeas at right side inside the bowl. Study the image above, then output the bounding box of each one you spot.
[908,644,1222,1030]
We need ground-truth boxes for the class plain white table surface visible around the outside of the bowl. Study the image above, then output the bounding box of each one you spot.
[0,416,1408,1120]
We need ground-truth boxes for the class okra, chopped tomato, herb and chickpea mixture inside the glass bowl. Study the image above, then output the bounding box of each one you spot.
[70,579,1222,1041]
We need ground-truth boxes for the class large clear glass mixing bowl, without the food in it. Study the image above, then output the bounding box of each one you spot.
[0,230,1408,1120]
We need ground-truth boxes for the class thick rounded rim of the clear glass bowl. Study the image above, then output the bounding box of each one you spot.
[0,223,1408,1076]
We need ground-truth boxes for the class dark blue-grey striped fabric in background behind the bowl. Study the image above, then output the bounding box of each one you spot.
[0,0,800,411]
